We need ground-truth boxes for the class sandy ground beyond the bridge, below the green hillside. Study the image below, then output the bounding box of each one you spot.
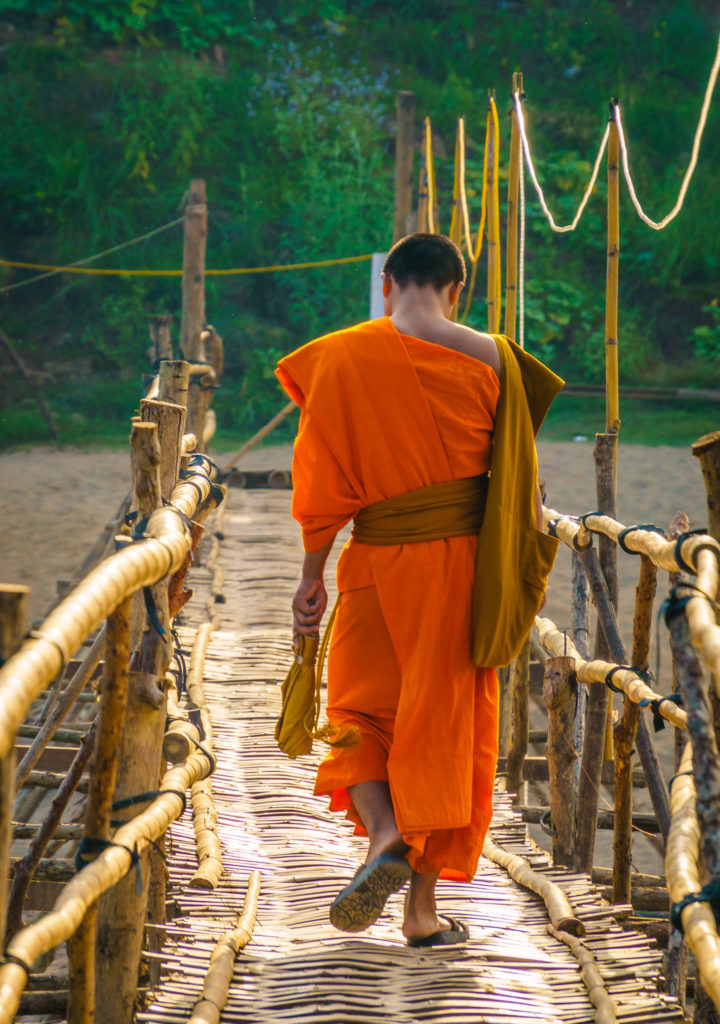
[0,441,707,872]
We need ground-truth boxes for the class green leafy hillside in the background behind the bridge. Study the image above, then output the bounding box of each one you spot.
[0,0,720,445]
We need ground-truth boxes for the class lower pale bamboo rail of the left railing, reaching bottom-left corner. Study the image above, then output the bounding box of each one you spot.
[0,751,212,1024]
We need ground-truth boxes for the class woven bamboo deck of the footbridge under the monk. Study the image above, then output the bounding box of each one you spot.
[138,488,682,1024]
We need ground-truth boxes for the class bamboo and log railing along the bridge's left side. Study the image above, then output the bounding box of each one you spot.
[0,181,259,1024]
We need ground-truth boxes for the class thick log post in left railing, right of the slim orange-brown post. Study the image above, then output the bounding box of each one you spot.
[95,422,171,1024]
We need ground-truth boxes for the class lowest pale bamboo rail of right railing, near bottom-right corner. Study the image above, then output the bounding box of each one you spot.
[665,742,720,1007]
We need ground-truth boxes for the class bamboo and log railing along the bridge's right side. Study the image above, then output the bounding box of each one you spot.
[518,434,720,1021]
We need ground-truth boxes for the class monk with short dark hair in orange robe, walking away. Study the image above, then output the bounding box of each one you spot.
[277,233,550,946]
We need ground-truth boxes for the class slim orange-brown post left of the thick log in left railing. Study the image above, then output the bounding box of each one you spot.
[68,598,132,1024]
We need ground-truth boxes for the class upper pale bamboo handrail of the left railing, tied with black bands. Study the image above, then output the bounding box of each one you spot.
[0,464,222,758]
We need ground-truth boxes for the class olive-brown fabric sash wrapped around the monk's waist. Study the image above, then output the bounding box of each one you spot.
[352,473,489,545]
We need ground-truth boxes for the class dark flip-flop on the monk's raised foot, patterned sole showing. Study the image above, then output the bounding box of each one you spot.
[330,853,412,932]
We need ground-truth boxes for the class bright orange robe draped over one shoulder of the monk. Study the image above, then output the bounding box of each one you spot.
[278,317,499,879]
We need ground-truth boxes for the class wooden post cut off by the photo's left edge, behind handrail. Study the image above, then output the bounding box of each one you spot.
[0,584,30,949]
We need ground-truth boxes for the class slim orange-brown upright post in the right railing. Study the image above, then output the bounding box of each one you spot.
[612,555,658,903]
